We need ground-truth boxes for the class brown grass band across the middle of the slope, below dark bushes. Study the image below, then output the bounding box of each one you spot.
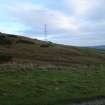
[0,44,105,66]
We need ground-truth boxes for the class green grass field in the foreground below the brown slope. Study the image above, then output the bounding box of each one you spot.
[0,65,105,105]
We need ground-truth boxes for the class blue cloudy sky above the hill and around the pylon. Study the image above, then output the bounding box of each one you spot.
[0,0,105,46]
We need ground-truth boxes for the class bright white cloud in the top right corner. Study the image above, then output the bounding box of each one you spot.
[65,0,105,20]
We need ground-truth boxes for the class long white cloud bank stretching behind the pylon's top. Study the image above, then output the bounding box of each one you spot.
[8,3,79,34]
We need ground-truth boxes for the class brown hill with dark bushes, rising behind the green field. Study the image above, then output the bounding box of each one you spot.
[0,33,105,66]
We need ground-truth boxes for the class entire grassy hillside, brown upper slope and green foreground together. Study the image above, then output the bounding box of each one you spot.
[0,33,105,105]
